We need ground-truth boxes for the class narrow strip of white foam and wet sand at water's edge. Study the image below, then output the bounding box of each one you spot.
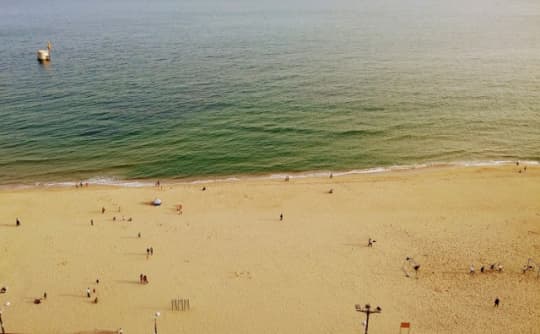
[0,160,540,191]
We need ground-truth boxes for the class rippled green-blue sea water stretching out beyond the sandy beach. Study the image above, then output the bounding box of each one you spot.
[0,0,540,184]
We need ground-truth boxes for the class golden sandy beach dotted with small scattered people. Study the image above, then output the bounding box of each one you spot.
[0,165,540,334]
